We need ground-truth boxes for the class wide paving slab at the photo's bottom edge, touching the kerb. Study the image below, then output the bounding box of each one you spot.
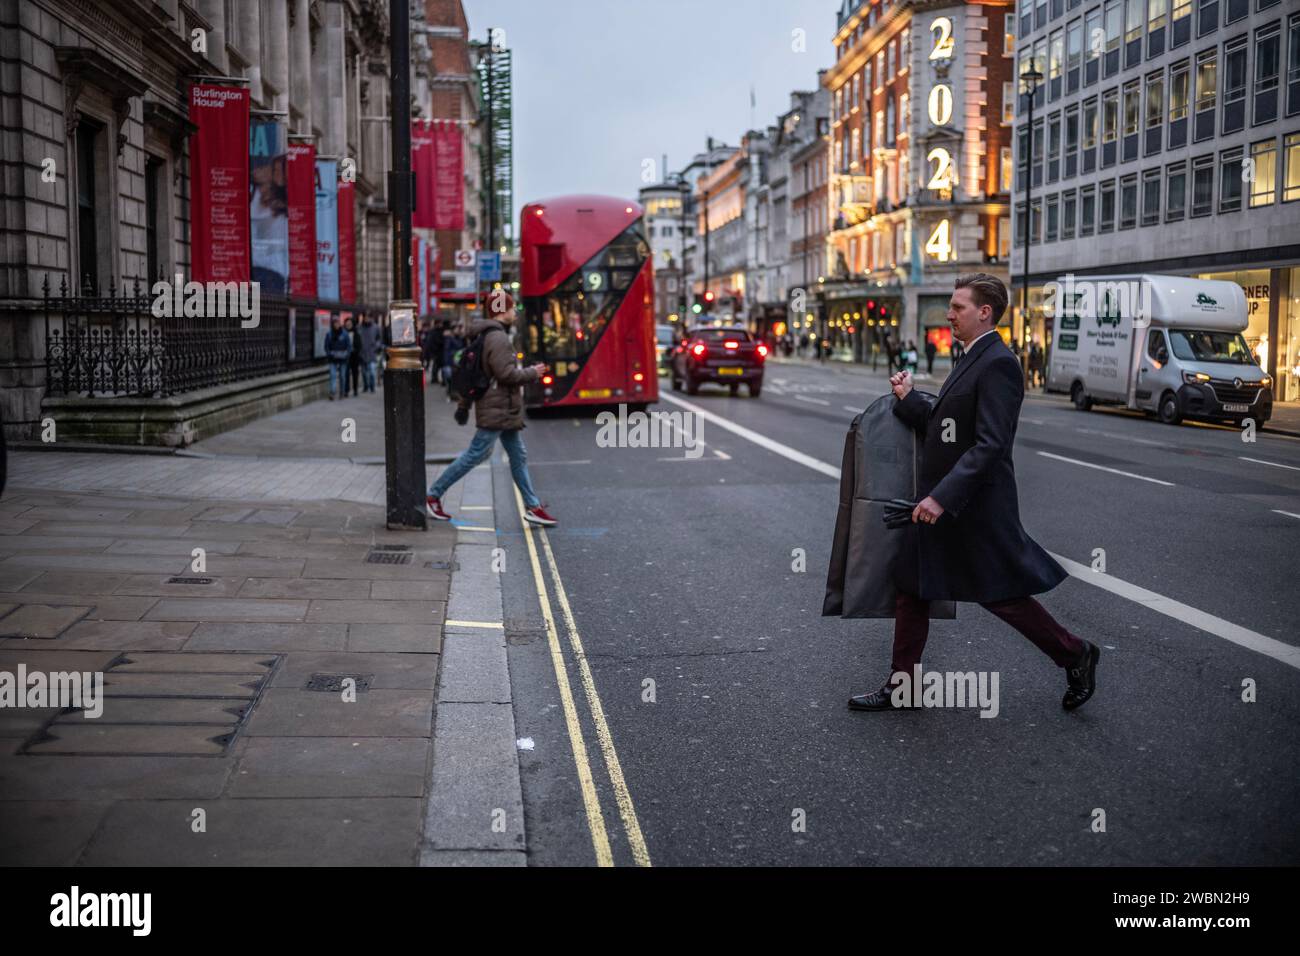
[81,797,421,866]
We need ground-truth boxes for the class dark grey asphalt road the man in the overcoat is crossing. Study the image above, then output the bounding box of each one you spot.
[483,365,1300,866]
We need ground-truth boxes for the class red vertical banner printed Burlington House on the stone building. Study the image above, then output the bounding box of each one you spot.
[189,83,250,282]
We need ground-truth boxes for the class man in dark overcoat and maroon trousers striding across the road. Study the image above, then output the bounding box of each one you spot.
[849,273,1101,710]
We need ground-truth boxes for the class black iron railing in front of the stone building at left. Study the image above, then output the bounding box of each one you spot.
[42,274,365,398]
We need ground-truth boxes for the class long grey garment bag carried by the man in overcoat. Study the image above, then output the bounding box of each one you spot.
[822,393,957,619]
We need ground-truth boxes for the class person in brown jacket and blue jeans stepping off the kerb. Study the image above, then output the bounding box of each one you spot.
[426,291,555,527]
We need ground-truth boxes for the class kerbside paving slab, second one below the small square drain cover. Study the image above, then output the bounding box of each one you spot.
[226,737,429,797]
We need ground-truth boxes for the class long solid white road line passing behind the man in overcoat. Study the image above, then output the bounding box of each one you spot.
[664,395,1300,670]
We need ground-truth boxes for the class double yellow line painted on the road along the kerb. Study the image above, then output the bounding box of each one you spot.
[514,488,650,866]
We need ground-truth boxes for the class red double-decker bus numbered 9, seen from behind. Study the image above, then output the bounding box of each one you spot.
[519,196,659,408]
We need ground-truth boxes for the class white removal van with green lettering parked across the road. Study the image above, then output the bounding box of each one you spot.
[1043,274,1273,425]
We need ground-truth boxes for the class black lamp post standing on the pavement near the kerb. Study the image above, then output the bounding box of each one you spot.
[384,0,428,531]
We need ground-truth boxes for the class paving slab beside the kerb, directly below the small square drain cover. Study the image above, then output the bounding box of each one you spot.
[244,687,433,737]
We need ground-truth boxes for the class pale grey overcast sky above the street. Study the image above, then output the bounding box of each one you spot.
[464,0,840,229]
